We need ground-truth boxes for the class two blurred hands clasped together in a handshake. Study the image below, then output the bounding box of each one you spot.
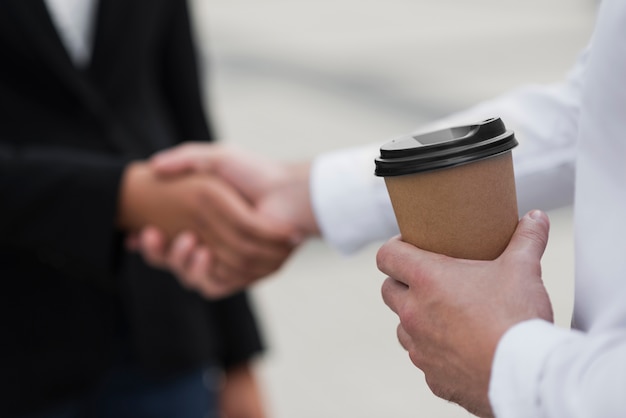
[117,143,319,298]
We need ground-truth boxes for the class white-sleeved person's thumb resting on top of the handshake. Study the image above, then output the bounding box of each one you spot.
[149,143,218,175]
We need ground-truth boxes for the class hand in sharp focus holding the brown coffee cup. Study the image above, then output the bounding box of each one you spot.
[377,211,553,417]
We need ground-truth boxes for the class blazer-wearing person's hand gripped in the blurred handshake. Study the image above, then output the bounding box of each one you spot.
[118,162,302,297]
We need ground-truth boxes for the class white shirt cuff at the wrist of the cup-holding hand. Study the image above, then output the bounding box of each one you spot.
[489,319,572,418]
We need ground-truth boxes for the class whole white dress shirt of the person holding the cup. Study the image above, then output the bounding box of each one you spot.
[311,0,626,418]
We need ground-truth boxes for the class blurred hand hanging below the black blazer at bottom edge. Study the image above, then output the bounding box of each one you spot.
[220,363,266,418]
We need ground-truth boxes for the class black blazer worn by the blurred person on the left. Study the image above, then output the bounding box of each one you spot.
[0,0,260,416]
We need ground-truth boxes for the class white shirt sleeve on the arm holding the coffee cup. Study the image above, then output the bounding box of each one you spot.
[489,320,626,418]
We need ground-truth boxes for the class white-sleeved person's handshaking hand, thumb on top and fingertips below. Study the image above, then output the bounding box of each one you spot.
[129,143,319,296]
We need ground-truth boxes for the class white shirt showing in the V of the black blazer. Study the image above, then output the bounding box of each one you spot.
[45,0,98,68]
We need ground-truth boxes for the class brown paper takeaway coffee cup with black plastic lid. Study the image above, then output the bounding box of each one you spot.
[375,118,518,260]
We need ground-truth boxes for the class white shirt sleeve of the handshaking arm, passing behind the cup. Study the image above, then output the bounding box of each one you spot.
[311,47,587,254]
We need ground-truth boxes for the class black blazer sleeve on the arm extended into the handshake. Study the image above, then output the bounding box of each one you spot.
[0,141,127,278]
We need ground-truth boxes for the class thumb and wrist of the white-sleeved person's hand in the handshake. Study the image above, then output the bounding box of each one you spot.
[150,143,320,236]
